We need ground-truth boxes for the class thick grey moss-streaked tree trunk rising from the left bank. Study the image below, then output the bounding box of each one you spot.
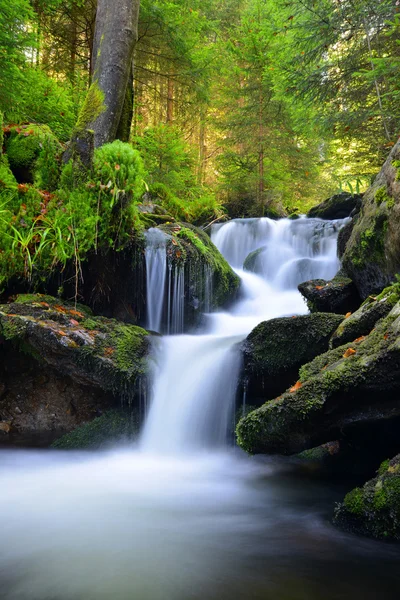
[89,0,140,148]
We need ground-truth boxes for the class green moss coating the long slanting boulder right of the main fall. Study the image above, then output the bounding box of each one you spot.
[237,305,400,454]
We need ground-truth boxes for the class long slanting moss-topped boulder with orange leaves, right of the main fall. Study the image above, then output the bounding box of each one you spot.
[237,302,400,454]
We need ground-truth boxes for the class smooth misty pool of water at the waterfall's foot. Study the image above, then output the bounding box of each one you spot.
[0,449,400,600]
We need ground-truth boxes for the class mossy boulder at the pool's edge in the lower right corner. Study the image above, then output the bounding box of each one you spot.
[334,454,400,541]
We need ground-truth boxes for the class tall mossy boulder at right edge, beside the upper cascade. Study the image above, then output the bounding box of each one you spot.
[342,142,400,299]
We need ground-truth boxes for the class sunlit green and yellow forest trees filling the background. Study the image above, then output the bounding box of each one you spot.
[0,0,400,222]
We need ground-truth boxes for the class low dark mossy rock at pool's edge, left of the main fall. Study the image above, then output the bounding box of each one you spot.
[52,410,139,450]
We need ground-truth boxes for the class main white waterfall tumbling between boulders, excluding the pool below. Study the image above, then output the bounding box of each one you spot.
[141,218,346,455]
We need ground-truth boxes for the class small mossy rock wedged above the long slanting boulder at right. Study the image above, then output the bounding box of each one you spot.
[330,283,400,348]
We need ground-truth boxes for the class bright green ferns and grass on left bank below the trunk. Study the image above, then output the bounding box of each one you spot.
[0,141,144,285]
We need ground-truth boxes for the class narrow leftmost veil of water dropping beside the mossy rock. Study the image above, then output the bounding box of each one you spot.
[145,228,168,333]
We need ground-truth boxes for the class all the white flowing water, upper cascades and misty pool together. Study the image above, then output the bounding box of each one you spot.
[0,219,399,600]
